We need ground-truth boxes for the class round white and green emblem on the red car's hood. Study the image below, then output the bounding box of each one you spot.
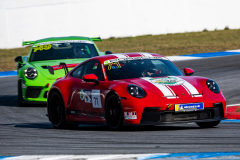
[149,76,184,86]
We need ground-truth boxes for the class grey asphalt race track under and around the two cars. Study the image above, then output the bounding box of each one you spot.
[0,55,240,156]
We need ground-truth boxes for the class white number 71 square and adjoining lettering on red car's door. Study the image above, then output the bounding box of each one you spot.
[79,89,102,108]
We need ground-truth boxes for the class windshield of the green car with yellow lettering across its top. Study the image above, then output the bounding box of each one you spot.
[30,43,98,62]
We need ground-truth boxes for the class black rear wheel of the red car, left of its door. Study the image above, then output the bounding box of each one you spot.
[48,91,79,129]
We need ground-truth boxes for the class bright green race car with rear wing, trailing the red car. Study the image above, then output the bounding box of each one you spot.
[15,36,112,105]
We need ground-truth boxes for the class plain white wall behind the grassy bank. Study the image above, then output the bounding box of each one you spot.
[0,0,240,48]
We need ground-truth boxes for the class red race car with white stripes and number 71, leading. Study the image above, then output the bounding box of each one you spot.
[47,53,226,130]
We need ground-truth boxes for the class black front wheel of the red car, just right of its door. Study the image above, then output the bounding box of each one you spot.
[105,94,123,131]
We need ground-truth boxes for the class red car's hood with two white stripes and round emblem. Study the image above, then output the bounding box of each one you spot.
[122,76,203,98]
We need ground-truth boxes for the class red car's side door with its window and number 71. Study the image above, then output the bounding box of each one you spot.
[68,60,105,122]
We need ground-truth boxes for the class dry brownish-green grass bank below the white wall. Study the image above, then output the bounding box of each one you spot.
[0,29,240,71]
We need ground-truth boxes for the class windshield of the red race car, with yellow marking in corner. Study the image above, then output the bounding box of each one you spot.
[104,59,184,80]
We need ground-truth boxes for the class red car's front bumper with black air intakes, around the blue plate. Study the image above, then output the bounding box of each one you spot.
[121,96,227,125]
